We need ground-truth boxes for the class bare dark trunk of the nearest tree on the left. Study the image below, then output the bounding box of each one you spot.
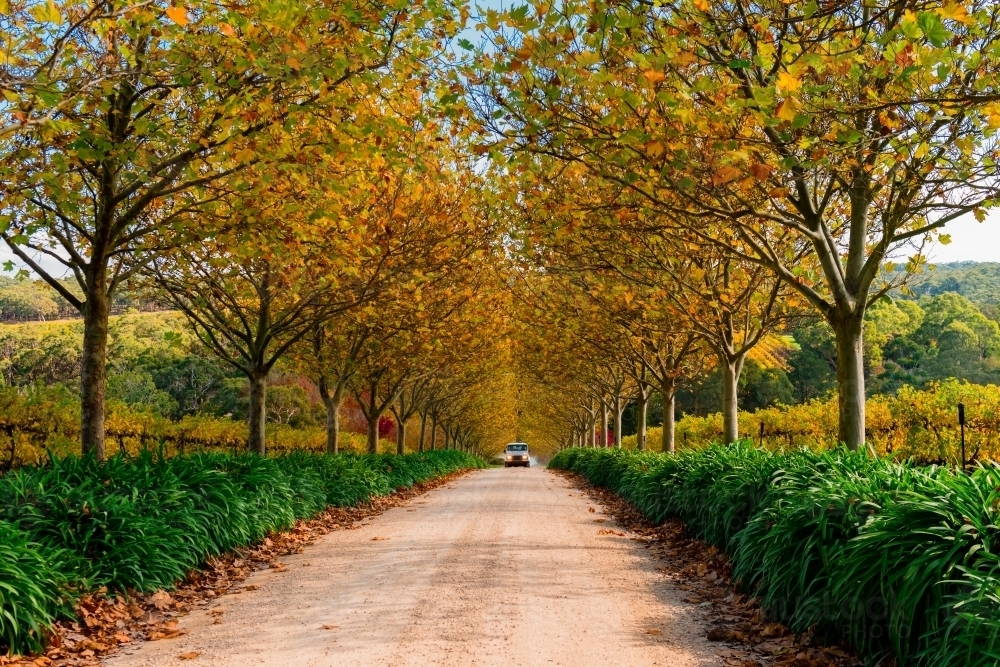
[80,284,109,461]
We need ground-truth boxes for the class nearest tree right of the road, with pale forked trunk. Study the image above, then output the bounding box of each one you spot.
[472,0,1000,448]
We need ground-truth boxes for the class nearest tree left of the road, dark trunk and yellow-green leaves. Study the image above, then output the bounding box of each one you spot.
[0,0,453,458]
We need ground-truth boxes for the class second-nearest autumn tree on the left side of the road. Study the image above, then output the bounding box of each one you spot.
[152,165,366,456]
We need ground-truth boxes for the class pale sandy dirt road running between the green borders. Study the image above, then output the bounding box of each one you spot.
[107,468,721,667]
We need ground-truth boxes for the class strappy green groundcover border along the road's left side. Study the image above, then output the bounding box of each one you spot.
[0,450,485,653]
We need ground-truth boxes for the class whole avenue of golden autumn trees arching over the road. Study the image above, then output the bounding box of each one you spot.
[0,0,1000,458]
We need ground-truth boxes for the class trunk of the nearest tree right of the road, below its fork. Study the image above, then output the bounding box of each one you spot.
[834,317,865,451]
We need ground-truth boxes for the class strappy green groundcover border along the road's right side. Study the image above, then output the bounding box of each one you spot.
[549,442,1000,667]
